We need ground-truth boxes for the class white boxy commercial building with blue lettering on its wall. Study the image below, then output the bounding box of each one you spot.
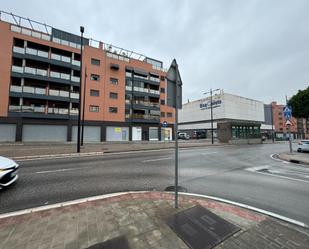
[179,90,264,141]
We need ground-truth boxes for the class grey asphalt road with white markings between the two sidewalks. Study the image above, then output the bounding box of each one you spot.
[0,144,309,225]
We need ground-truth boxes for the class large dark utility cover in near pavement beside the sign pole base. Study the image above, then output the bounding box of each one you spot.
[167,206,240,249]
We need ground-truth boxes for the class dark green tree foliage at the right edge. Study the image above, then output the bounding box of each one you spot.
[288,87,309,119]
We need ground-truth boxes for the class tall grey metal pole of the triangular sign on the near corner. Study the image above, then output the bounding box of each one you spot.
[174,63,178,208]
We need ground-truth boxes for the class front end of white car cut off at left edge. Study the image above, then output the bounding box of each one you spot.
[0,156,19,189]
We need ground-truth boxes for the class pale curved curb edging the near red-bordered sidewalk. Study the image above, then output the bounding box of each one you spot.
[0,191,309,228]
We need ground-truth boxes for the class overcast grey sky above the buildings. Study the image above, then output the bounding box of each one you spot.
[0,0,309,103]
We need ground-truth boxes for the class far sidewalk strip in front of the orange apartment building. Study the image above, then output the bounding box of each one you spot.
[0,139,222,158]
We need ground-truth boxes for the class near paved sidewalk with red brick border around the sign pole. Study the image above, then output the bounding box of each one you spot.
[0,192,309,249]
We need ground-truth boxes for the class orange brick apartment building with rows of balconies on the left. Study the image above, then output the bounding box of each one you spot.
[0,12,175,142]
